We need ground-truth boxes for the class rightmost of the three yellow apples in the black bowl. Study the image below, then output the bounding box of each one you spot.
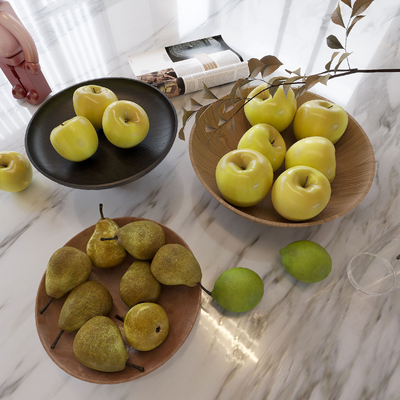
[103,100,149,149]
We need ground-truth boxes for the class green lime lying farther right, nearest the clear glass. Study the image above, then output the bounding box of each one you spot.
[279,240,332,283]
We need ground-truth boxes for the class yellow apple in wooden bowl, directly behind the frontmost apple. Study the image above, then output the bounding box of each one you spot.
[285,136,336,182]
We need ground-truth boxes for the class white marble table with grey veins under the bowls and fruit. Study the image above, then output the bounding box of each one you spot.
[0,0,400,400]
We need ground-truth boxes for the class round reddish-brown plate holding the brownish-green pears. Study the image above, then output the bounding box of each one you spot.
[35,217,201,384]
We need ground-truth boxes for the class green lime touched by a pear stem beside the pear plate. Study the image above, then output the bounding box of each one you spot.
[208,267,264,312]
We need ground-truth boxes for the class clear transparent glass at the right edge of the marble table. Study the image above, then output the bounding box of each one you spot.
[347,224,400,296]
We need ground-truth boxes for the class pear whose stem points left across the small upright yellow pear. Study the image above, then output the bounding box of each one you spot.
[102,220,165,260]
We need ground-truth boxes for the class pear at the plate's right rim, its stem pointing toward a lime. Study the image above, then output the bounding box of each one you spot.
[151,243,202,287]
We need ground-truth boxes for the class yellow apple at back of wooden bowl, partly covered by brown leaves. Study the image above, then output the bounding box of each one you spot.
[244,83,297,132]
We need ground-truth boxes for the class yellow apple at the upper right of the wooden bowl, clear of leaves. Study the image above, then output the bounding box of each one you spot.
[293,100,349,144]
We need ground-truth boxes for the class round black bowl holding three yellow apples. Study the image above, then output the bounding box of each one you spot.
[25,78,178,189]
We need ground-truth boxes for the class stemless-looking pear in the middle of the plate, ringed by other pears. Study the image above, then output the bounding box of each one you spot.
[119,260,161,308]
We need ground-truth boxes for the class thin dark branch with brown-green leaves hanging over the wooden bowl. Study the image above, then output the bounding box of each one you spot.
[179,0,400,140]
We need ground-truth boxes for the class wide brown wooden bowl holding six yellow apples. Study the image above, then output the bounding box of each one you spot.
[189,92,375,227]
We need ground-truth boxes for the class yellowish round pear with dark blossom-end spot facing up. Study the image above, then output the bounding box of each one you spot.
[124,302,169,351]
